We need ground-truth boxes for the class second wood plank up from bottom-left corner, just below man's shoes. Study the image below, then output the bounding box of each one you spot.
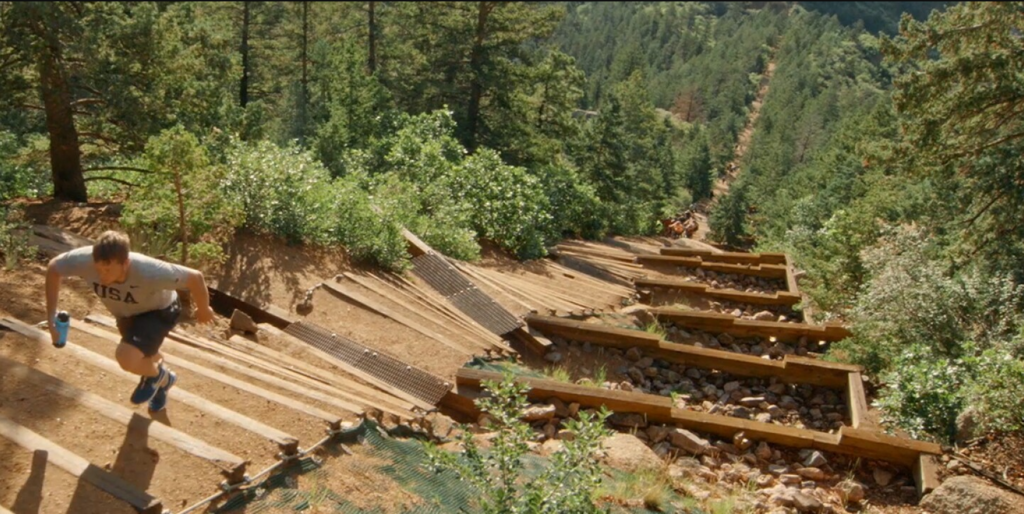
[0,356,246,477]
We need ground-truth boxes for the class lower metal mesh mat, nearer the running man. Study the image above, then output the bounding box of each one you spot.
[285,322,452,405]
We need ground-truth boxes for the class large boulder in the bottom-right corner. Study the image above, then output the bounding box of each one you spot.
[920,475,1024,514]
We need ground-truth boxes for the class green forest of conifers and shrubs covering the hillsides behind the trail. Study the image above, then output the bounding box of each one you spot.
[0,1,1024,438]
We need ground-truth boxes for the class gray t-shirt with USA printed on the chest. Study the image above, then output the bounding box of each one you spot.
[53,246,189,317]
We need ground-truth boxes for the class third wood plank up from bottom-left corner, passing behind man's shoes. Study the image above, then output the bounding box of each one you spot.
[0,317,299,452]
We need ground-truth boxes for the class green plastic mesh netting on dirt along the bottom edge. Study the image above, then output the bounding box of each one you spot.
[210,413,700,514]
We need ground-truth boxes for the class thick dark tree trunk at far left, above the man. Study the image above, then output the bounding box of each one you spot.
[39,29,88,202]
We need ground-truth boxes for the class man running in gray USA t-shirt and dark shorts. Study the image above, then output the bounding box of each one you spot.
[46,230,213,412]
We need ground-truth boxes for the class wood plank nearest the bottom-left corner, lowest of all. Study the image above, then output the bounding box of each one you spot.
[0,415,164,514]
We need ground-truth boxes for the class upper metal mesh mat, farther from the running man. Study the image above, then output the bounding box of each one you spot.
[413,254,520,336]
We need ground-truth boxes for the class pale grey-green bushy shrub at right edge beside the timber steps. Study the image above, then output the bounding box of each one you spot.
[835,226,1024,373]
